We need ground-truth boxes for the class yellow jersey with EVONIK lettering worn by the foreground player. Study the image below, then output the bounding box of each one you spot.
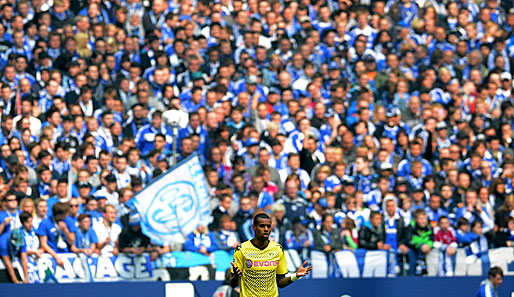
[232,240,288,297]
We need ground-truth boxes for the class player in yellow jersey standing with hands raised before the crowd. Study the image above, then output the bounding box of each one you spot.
[230,213,312,297]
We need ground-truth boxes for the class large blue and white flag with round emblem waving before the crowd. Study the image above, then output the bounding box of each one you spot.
[129,154,210,245]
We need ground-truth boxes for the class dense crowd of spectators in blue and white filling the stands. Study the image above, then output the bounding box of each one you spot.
[0,0,514,282]
